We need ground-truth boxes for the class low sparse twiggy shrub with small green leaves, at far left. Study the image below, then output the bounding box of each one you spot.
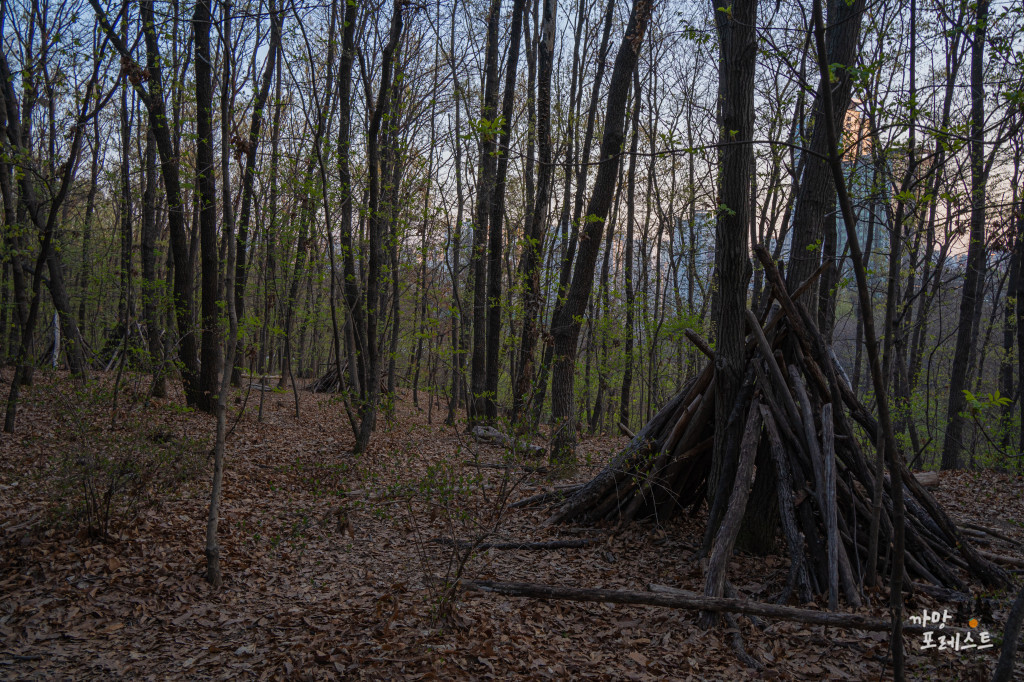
[32,372,209,539]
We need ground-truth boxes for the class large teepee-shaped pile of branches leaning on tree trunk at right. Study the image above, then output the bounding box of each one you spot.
[551,248,1009,608]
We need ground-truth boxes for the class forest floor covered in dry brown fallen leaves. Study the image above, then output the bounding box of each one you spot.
[0,371,1024,680]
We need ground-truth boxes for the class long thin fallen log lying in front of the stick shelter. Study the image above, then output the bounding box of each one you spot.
[460,581,972,635]
